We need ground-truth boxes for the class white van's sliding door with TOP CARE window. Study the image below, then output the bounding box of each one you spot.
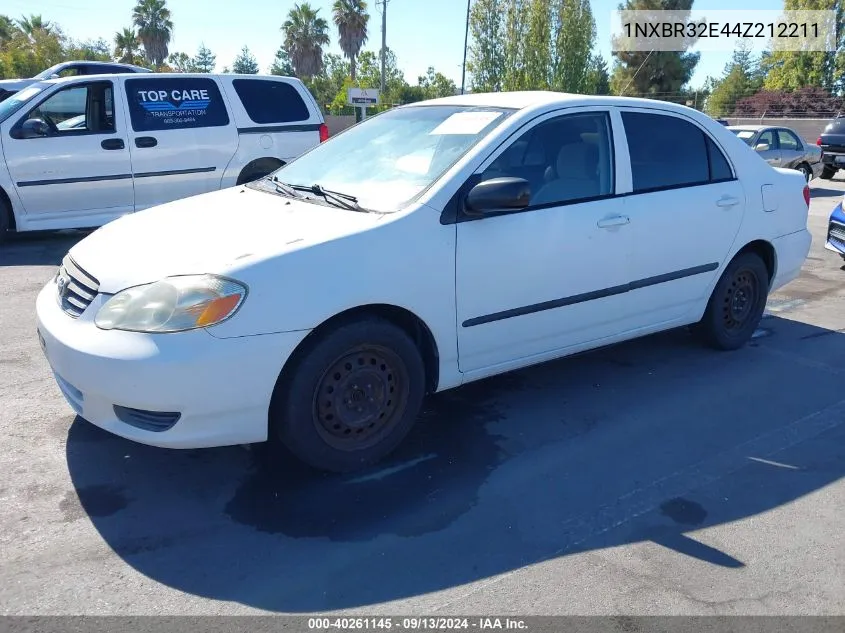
[119,75,238,211]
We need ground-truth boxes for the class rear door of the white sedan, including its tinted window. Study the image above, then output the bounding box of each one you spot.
[621,108,744,327]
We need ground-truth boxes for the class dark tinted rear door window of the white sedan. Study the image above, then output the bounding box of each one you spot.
[622,112,733,193]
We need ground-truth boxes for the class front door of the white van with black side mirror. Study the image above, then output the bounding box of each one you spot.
[2,81,133,228]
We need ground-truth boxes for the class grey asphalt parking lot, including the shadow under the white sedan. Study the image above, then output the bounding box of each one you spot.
[0,180,845,615]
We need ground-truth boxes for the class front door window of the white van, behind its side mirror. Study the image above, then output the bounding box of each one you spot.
[22,82,115,136]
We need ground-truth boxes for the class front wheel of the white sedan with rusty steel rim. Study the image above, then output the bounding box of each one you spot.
[270,318,425,472]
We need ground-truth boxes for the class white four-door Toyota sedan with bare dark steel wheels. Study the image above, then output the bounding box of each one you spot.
[37,92,811,471]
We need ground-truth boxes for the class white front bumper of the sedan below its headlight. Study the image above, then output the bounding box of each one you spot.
[36,282,307,448]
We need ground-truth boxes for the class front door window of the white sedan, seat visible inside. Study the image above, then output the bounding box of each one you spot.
[482,112,614,207]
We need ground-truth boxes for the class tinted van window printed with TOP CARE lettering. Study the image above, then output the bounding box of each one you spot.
[126,77,229,132]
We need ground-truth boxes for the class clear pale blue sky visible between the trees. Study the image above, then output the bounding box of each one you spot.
[8,0,783,86]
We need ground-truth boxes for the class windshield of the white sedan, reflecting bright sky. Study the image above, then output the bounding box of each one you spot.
[275,105,511,212]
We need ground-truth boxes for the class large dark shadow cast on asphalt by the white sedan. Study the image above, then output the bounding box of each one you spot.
[62,316,845,612]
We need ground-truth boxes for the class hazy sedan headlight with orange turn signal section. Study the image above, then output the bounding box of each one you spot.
[94,275,247,332]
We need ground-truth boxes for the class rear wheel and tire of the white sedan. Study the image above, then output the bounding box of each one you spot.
[695,253,769,351]
